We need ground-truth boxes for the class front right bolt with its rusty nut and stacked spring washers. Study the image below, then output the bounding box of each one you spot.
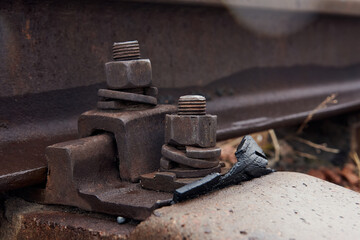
[160,95,223,178]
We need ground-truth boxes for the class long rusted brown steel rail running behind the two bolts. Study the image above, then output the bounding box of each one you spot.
[0,0,360,190]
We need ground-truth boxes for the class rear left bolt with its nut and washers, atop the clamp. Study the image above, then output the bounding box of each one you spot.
[97,41,158,109]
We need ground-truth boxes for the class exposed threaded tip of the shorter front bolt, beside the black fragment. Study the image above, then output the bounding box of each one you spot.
[178,95,206,115]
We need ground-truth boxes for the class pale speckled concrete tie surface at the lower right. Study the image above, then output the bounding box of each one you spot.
[130,172,360,240]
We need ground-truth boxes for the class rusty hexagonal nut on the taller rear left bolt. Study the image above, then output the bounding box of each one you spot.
[105,59,152,89]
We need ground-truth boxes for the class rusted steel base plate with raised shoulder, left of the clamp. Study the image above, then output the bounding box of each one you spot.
[23,134,171,220]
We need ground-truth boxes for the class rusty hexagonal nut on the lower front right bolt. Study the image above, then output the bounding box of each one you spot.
[165,114,217,147]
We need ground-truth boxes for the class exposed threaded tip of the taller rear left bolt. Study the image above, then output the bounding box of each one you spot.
[113,40,140,61]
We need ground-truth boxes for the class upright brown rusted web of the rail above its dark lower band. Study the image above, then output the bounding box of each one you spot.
[0,0,360,97]
